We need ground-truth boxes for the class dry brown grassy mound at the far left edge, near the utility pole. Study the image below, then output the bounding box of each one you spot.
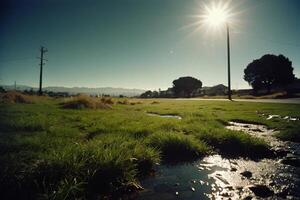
[0,91,32,103]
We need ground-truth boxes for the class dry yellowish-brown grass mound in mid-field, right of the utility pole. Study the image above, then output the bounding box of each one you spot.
[62,95,111,109]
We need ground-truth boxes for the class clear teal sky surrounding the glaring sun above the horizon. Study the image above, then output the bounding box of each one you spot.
[0,0,300,90]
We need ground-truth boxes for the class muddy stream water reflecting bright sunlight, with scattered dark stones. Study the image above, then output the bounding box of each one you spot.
[139,122,300,200]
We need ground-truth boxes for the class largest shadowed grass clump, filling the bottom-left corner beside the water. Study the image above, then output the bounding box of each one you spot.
[1,135,159,199]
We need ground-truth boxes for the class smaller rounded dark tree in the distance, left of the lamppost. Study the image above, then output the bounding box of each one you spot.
[173,76,202,97]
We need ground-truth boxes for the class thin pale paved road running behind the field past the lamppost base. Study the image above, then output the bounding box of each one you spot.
[176,98,300,104]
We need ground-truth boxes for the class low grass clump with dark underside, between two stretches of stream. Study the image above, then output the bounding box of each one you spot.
[198,129,273,159]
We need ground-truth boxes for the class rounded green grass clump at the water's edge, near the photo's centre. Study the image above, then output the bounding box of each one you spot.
[148,132,209,161]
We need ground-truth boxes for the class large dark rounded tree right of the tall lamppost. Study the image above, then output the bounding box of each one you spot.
[244,54,295,93]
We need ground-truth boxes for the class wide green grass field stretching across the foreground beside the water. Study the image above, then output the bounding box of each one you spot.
[0,98,300,199]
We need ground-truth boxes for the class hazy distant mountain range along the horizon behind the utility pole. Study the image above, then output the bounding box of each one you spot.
[1,85,146,97]
